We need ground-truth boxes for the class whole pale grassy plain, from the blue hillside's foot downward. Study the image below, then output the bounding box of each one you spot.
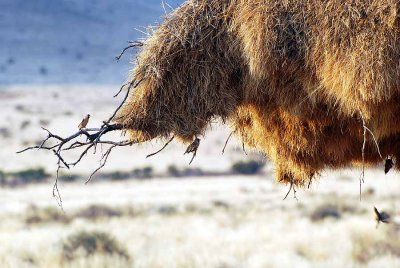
[0,86,400,268]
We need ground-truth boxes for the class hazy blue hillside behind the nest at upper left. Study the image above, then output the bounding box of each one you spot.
[0,0,183,84]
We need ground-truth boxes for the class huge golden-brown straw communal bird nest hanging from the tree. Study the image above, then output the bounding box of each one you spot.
[115,0,400,185]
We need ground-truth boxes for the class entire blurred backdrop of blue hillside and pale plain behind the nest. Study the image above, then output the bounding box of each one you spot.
[0,0,400,268]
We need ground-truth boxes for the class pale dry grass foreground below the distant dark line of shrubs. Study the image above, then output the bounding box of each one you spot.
[0,171,400,268]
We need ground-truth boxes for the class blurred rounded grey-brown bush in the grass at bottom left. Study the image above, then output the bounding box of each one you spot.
[62,231,129,260]
